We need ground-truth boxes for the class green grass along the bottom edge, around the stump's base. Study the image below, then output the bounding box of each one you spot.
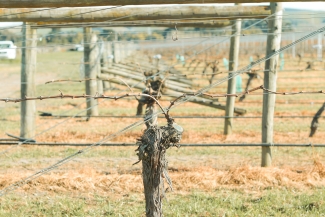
[0,189,325,217]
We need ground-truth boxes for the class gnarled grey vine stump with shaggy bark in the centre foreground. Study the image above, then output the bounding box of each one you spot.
[136,121,183,217]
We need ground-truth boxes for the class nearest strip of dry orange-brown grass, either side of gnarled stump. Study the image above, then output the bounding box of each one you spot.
[0,157,325,195]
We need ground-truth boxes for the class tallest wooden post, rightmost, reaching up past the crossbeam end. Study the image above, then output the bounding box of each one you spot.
[261,3,283,167]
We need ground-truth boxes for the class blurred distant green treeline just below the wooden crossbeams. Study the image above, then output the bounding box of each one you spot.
[0,19,298,45]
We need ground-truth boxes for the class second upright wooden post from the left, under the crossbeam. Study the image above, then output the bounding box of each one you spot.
[83,27,99,116]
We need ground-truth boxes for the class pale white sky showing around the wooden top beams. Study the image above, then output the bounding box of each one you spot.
[0,2,325,27]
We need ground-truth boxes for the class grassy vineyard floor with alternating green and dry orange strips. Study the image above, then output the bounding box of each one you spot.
[0,52,325,216]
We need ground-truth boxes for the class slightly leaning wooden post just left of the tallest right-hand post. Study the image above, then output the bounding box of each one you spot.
[224,5,241,135]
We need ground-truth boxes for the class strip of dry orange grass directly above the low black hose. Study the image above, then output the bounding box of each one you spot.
[32,124,325,144]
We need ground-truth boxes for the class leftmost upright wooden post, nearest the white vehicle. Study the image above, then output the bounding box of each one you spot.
[20,23,37,138]
